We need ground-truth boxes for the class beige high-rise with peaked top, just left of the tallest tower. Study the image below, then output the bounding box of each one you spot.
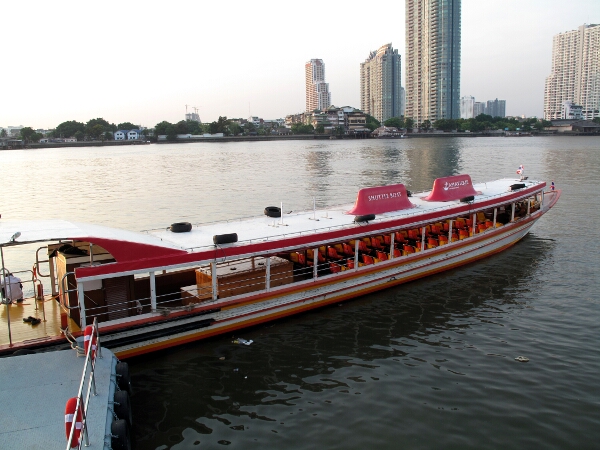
[360,44,402,122]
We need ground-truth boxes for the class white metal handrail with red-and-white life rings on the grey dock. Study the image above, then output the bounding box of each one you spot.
[65,319,102,450]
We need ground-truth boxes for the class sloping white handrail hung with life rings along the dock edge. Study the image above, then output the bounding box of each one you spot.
[66,318,102,450]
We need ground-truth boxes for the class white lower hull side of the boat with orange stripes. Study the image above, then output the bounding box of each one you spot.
[103,207,541,358]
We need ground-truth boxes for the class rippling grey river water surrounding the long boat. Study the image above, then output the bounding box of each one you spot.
[0,137,600,450]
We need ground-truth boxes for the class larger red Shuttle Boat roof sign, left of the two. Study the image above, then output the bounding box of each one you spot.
[347,184,413,216]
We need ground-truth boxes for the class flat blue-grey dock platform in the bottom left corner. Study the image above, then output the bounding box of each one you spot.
[0,348,118,450]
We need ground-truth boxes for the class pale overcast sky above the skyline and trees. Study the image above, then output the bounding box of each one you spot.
[0,0,600,128]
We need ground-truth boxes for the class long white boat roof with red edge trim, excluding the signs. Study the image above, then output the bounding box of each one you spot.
[0,177,546,278]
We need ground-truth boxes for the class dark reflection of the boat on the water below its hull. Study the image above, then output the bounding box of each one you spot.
[132,236,554,448]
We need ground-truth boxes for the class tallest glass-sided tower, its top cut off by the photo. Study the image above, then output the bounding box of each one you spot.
[404,0,461,124]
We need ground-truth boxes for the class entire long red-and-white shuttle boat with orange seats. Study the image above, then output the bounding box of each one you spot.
[0,175,560,359]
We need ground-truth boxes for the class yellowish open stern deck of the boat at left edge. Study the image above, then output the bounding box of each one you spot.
[0,296,80,345]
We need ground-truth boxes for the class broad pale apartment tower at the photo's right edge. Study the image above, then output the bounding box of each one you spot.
[544,25,600,120]
